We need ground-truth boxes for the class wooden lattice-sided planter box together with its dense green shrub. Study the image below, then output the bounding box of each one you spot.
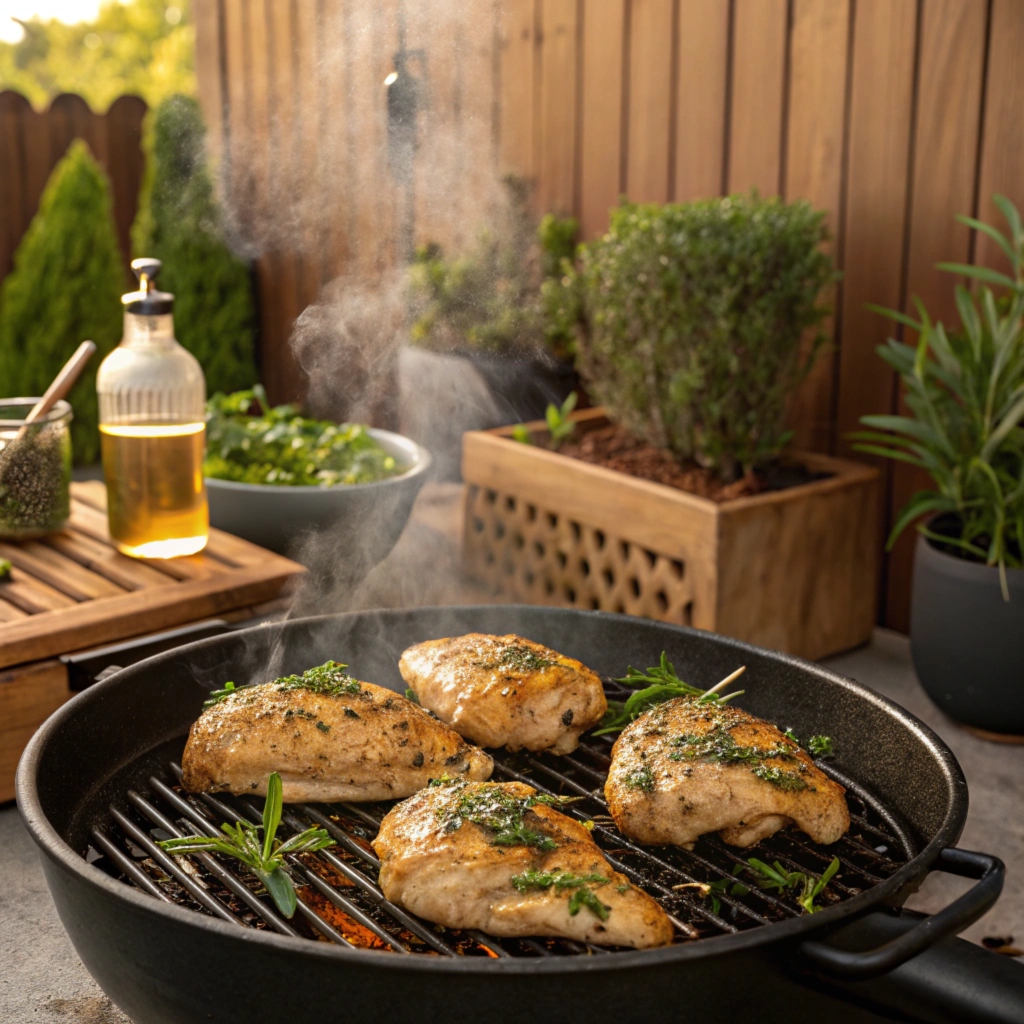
[463,194,879,657]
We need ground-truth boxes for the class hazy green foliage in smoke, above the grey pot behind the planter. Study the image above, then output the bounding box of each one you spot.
[409,175,579,358]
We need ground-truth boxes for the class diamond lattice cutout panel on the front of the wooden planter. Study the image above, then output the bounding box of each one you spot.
[465,485,693,626]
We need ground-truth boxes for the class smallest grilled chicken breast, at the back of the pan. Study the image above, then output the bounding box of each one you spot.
[398,633,607,754]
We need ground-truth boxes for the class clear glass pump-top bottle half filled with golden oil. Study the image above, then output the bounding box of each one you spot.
[96,259,209,558]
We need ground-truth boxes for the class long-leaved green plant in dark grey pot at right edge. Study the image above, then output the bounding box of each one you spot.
[856,196,1024,736]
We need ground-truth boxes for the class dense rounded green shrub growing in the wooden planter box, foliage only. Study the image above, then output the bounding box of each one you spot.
[573,193,836,481]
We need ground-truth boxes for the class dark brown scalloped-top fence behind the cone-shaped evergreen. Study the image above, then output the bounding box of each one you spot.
[0,90,146,281]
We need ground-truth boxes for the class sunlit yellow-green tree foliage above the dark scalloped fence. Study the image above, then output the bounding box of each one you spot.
[0,0,196,112]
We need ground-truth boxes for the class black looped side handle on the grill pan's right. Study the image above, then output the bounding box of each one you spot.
[800,849,1006,979]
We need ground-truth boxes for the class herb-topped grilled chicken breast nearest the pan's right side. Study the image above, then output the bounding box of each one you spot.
[604,697,850,849]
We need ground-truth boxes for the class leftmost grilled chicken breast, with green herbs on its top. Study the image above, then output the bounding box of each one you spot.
[181,662,494,802]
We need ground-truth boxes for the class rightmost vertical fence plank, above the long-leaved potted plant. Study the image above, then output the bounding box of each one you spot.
[975,0,1024,271]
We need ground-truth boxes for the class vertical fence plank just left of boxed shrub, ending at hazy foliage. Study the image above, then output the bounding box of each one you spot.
[537,0,579,214]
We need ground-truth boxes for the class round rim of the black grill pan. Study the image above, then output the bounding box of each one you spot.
[15,605,968,975]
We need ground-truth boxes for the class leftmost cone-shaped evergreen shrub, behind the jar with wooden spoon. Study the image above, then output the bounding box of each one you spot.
[0,139,126,464]
